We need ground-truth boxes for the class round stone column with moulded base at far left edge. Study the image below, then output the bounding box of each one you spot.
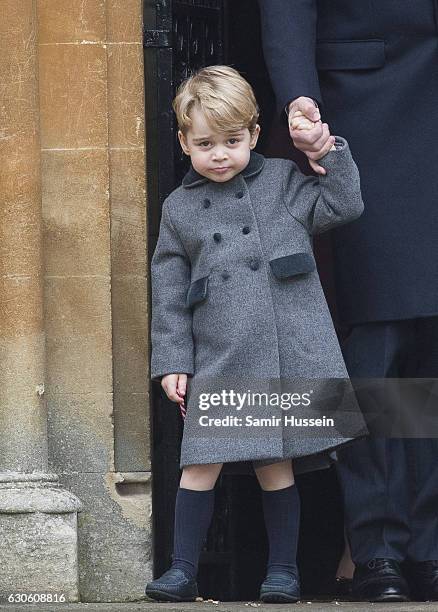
[0,0,80,601]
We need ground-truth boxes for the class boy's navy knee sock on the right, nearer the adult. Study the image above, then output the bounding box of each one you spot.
[262,484,300,576]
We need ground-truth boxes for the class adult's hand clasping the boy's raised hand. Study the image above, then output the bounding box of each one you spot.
[289,96,335,174]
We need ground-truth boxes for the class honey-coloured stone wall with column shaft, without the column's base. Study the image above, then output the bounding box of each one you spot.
[0,0,152,601]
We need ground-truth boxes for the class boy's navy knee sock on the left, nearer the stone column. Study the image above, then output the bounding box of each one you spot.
[171,487,214,578]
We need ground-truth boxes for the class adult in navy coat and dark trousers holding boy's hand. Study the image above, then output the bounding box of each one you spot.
[259,0,438,601]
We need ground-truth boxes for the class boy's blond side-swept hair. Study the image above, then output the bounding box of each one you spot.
[173,66,259,134]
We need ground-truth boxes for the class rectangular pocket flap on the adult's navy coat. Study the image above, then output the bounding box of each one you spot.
[316,40,385,70]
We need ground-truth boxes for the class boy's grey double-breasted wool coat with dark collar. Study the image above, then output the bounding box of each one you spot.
[151,137,363,472]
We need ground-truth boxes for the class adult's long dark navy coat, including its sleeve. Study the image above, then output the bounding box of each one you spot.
[259,0,438,323]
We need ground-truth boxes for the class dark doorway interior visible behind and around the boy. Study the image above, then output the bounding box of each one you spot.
[144,0,343,601]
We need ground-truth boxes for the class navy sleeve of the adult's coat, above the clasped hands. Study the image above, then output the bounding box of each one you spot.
[259,0,323,113]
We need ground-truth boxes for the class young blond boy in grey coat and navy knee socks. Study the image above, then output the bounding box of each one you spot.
[146,66,363,602]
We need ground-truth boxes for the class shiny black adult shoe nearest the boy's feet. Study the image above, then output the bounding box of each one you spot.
[352,559,409,601]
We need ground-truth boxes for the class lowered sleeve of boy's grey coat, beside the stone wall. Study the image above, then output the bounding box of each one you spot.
[151,201,194,380]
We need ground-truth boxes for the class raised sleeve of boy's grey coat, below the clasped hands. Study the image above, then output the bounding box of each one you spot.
[283,136,364,235]
